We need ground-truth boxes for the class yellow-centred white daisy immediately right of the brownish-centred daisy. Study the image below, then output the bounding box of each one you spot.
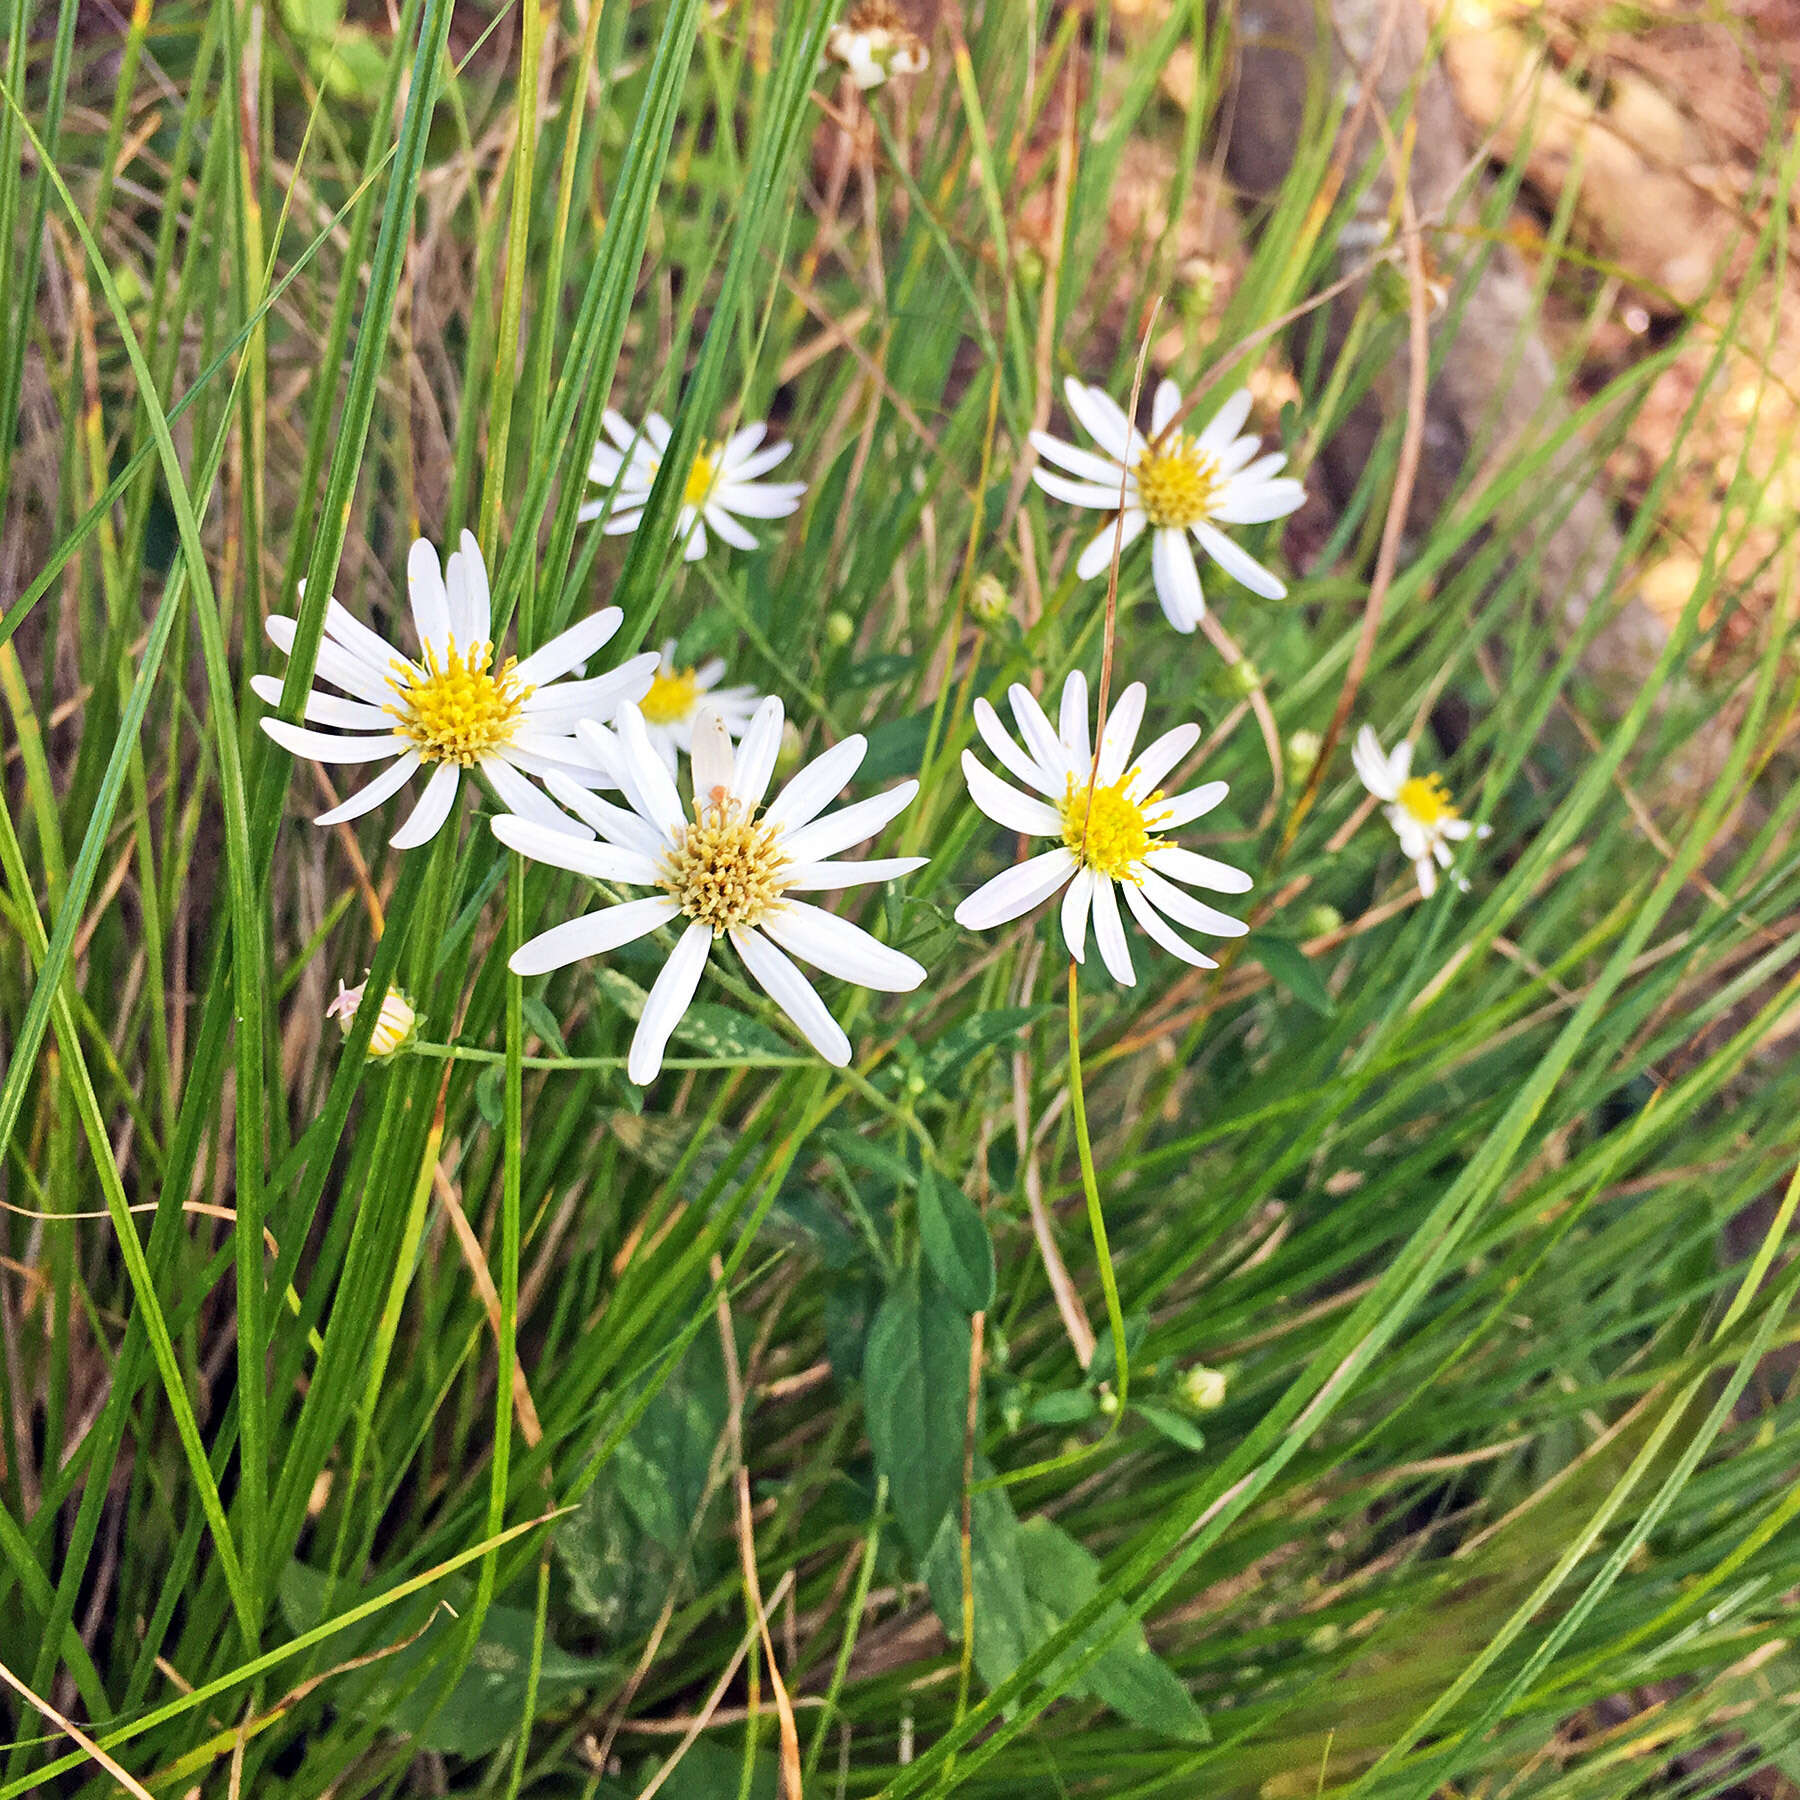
[956,670,1253,986]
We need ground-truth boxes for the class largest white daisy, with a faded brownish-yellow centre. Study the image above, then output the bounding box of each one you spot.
[493,697,925,1084]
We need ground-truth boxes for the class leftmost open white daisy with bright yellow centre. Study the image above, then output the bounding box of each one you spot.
[250,531,657,850]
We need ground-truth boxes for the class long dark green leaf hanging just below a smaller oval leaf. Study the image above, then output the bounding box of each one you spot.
[862,1273,970,1559]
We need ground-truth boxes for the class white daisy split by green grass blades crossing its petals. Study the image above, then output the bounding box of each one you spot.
[576,407,806,562]
